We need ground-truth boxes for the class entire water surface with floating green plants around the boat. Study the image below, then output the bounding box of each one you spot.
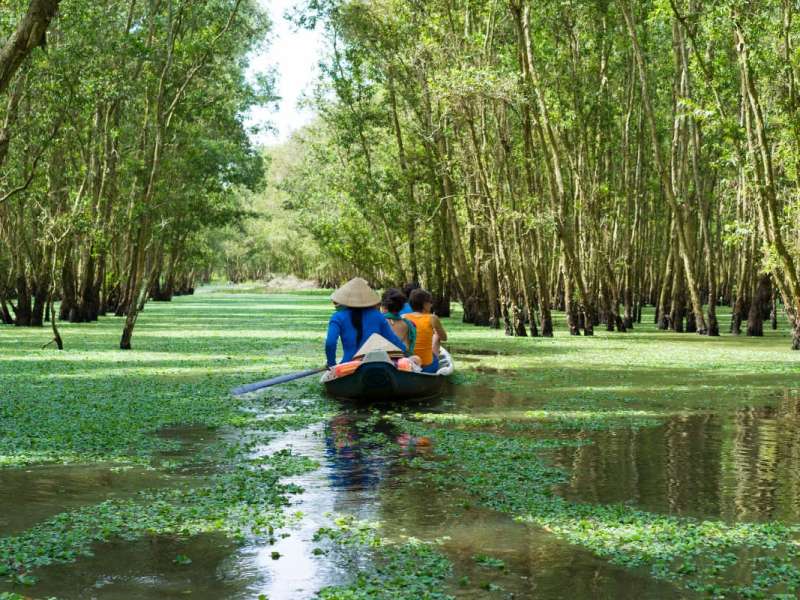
[0,294,800,600]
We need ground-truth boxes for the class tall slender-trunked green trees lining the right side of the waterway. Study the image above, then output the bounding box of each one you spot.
[270,0,800,348]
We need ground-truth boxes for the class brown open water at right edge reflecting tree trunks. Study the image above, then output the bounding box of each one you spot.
[553,397,800,522]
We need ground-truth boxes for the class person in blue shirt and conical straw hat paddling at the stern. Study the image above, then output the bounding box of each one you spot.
[325,277,406,367]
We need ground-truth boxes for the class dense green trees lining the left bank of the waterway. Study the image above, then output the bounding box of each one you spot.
[0,0,270,348]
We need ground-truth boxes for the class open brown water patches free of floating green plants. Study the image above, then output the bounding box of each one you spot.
[0,388,800,600]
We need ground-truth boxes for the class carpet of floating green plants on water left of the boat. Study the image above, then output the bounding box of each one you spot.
[0,295,331,584]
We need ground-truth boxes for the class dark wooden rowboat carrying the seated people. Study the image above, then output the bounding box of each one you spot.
[322,348,454,402]
